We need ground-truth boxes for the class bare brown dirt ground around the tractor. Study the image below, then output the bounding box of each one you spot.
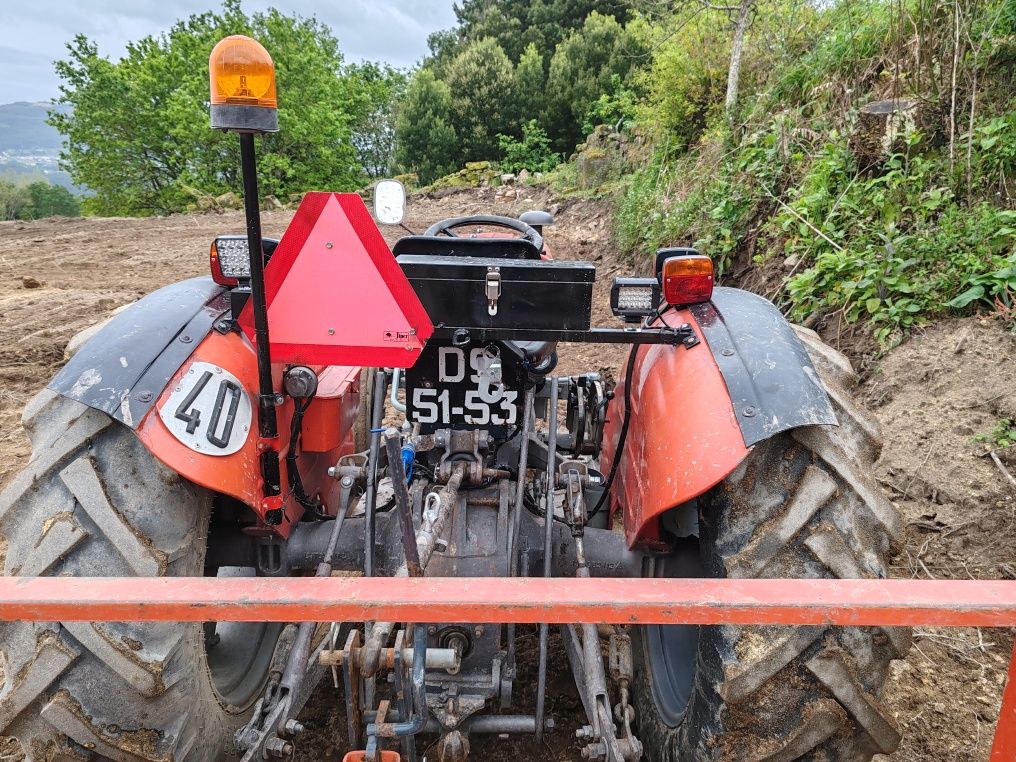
[0,189,1016,762]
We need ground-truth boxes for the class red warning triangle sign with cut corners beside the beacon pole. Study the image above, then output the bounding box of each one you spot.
[240,193,434,368]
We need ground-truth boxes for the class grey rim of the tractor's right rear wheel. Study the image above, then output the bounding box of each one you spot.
[643,539,707,727]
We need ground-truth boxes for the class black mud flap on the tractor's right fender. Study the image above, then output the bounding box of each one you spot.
[691,289,837,447]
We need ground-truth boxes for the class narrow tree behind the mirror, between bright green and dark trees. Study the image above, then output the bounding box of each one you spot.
[346,62,407,178]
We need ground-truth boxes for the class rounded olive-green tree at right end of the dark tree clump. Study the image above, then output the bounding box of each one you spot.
[547,11,641,153]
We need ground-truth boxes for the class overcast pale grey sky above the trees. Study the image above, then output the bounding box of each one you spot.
[0,0,455,104]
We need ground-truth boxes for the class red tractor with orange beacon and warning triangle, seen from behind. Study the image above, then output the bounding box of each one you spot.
[0,32,909,762]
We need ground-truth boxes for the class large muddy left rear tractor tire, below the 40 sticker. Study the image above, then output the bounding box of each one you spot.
[0,391,279,762]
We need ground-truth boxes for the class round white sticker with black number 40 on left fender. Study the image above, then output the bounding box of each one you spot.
[158,363,253,455]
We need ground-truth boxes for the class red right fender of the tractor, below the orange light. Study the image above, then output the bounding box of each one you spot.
[600,310,750,548]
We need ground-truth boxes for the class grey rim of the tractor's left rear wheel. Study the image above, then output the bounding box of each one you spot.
[204,566,282,710]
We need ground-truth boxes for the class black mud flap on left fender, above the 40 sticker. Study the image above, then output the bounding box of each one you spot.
[48,277,229,429]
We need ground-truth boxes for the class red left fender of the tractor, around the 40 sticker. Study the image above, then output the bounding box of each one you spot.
[137,331,361,537]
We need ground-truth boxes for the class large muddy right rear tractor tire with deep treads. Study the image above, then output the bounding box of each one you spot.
[632,331,910,762]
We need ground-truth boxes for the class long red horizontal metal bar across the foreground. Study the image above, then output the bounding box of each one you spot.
[0,577,1016,627]
